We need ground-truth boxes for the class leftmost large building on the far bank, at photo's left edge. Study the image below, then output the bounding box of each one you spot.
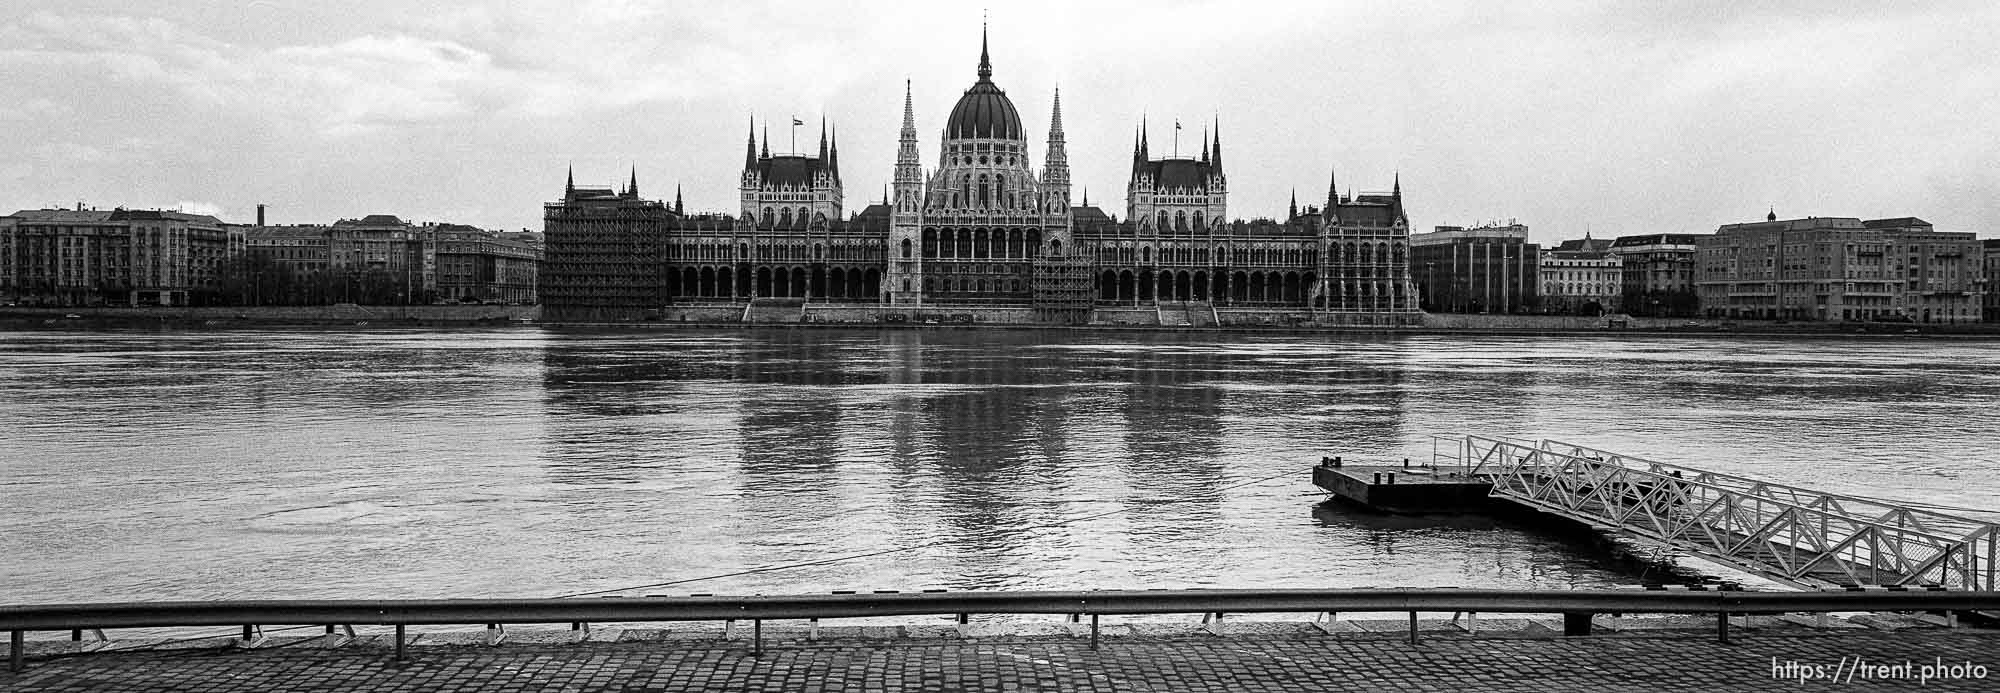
[0,206,244,306]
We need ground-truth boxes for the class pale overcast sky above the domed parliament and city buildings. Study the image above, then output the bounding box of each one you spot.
[0,0,2000,240]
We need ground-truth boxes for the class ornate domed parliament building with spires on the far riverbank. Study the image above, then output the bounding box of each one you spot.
[542,30,1422,326]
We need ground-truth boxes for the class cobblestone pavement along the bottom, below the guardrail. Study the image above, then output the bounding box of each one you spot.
[0,629,2000,693]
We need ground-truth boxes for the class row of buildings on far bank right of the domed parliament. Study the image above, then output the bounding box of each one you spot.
[1410,212,2000,322]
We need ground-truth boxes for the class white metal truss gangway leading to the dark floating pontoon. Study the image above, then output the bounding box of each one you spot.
[1432,435,2000,591]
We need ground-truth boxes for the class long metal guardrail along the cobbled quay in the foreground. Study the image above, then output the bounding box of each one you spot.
[15,587,2000,671]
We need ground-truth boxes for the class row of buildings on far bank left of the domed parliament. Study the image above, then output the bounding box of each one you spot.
[0,204,542,306]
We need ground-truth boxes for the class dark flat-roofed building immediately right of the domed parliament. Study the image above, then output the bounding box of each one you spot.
[1410,224,1542,312]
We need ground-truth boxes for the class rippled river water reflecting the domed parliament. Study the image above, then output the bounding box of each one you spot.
[0,328,2000,603]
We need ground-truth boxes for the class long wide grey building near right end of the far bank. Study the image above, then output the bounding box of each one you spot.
[1696,214,1982,322]
